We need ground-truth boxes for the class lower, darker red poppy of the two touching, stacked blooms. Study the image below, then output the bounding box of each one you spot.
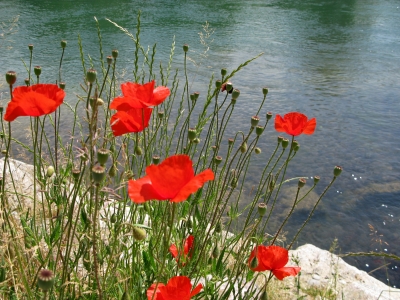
[110,107,153,136]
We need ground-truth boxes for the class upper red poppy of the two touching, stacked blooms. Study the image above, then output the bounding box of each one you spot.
[110,80,170,111]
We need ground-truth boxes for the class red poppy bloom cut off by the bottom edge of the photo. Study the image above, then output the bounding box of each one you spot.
[147,276,203,300]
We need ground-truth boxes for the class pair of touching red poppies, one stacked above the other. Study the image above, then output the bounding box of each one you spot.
[110,80,170,136]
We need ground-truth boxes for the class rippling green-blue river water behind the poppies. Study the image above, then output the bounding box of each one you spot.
[0,0,400,286]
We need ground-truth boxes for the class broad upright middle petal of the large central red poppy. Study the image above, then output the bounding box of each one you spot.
[146,155,194,201]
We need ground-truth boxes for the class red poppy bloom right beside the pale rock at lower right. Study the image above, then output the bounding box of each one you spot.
[249,245,301,280]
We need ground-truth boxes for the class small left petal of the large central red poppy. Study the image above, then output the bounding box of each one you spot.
[128,176,162,203]
